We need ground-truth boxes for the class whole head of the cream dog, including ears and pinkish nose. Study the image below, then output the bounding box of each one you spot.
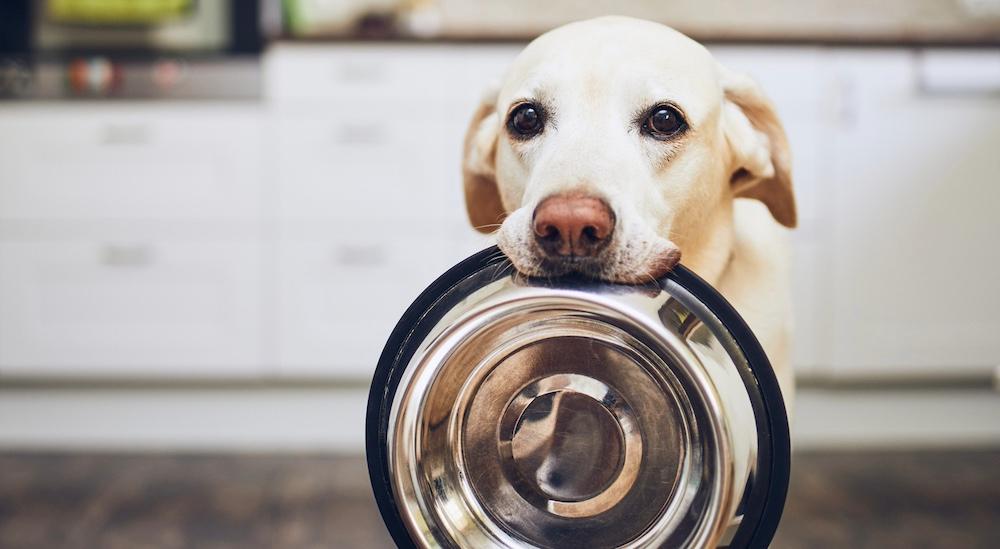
[463,17,795,283]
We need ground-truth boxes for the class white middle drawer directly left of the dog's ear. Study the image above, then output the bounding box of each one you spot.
[277,110,461,221]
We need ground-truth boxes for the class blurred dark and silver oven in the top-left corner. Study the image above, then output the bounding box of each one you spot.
[0,0,263,100]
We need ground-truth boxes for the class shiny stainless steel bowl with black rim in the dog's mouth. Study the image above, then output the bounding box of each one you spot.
[367,248,789,547]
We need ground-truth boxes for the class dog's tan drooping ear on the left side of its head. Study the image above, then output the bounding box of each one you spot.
[462,87,506,233]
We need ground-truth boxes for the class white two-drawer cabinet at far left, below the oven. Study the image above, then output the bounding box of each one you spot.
[0,103,267,377]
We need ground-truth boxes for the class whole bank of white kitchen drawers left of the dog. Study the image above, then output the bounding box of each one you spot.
[0,45,520,378]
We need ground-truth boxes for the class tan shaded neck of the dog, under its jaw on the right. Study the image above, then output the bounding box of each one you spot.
[673,201,736,285]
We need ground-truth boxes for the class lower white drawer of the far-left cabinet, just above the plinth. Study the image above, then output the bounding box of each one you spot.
[0,241,262,376]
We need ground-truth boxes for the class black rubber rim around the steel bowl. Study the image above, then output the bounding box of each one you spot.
[365,246,791,548]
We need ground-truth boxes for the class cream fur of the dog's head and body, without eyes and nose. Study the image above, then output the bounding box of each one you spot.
[463,17,796,405]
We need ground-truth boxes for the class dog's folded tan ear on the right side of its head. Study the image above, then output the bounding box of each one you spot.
[720,65,797,227]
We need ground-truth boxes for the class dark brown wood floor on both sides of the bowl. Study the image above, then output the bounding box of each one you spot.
[0,451,1000,549]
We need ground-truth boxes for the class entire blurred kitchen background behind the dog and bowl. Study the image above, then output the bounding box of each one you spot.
[0,0,1000,548]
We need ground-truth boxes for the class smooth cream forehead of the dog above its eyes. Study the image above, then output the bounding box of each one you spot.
[500,17,721,116]
